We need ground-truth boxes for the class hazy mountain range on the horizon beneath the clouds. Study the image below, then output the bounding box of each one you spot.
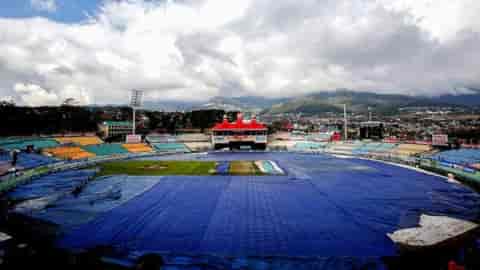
[144,90,480,114]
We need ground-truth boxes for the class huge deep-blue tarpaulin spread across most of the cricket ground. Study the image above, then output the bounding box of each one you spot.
[4,153,480,269]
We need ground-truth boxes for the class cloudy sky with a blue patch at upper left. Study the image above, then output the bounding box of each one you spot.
[0,0,480,106]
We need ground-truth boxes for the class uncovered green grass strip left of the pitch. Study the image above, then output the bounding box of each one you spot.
[98,160,215,176]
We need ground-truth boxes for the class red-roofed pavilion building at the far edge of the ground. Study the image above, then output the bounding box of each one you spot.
[212,113,267,150]
